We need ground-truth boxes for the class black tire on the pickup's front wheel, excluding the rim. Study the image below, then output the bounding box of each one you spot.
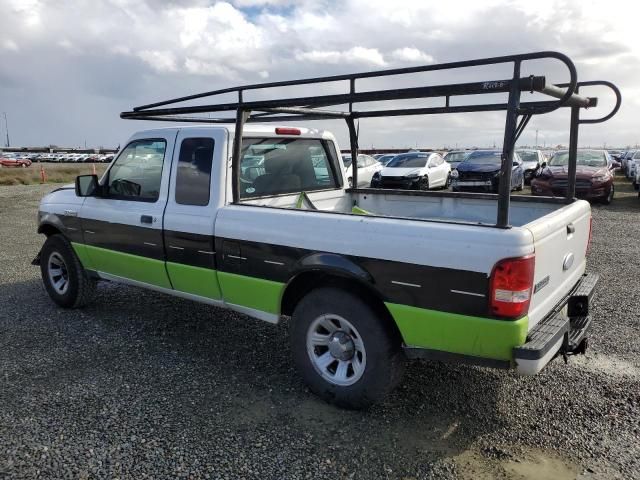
[40,234,97,308]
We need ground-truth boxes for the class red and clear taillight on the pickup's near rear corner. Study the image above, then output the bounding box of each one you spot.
[489,255,535,318]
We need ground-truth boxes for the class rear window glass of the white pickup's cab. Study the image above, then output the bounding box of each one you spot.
[239,138,340,198]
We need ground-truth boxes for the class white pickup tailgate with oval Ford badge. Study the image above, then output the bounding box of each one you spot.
[524,200,591,329]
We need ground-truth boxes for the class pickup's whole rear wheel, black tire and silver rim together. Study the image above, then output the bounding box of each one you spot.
[291,287,405,409]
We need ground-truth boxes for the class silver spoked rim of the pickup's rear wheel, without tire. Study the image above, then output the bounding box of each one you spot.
[307,313,367,387]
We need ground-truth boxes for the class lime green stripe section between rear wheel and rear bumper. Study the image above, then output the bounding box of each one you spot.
[386,303,529,361]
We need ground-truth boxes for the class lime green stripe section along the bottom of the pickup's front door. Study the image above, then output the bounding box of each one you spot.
[71,243,171,288]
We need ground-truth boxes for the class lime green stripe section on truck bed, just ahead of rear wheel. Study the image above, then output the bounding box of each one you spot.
[218,271,285,315]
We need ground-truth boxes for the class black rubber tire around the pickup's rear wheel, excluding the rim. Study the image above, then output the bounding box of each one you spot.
[291,287,405,409]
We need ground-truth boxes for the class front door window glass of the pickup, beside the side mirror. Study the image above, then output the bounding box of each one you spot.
[107,140,167,202]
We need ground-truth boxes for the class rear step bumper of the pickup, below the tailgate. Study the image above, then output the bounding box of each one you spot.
[513,273,598,375]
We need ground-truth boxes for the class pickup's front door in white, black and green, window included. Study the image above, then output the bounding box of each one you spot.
[80,130,176,288]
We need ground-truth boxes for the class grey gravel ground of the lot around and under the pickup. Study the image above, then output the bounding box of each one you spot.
[0,184,640,479]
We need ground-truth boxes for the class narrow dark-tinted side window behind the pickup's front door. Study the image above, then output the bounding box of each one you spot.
[176,138,214,206]
